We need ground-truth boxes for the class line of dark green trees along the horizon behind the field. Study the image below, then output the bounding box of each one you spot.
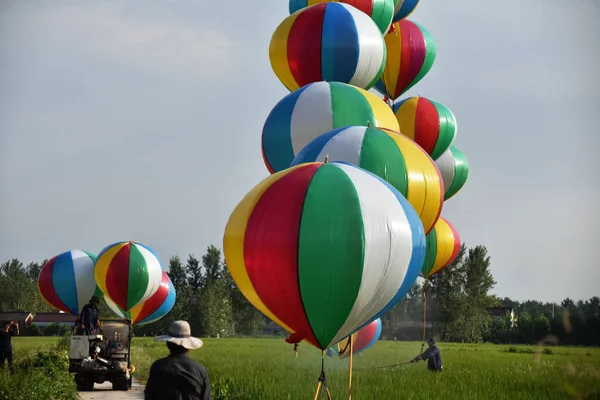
[0,244,600,346]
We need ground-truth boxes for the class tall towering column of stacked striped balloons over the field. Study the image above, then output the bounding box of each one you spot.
[224,0,468,354]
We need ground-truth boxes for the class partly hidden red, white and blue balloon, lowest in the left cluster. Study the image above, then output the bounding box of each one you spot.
[105,271,176,325]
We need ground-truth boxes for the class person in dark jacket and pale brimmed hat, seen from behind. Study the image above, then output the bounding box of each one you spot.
[144,321,212,400]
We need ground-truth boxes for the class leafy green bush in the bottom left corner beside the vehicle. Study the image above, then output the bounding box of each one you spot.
[0,349,79,400]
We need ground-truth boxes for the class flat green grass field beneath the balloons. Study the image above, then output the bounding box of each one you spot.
[13,338,600,400]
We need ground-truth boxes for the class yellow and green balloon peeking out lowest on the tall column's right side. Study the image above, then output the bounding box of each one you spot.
[421,217,460,278]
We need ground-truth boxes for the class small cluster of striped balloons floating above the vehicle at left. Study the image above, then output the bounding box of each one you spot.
[38,242,176,325]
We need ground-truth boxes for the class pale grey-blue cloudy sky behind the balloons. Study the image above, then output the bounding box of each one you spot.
[0,0,600,301]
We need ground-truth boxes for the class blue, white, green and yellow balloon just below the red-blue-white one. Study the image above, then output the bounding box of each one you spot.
[262,82,398,173]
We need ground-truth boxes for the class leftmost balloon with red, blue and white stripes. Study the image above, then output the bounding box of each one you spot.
[38,250,102,315]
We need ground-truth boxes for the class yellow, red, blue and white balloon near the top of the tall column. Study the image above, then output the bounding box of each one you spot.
[269,3,386,91]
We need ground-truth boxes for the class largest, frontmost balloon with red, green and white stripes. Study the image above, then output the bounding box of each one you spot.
[224,163,425,349]
